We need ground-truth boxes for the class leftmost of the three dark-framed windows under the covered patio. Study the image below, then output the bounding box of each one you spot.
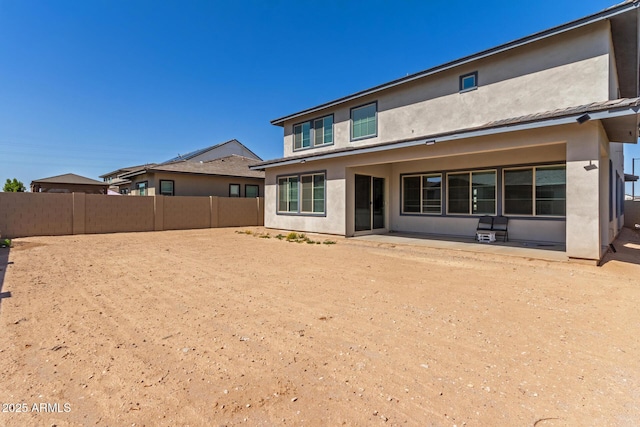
[402,174,442,214]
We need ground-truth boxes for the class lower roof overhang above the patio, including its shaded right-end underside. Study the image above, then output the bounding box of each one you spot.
[249,98,640,170]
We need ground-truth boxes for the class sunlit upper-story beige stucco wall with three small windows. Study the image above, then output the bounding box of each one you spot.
[284,22,617,157]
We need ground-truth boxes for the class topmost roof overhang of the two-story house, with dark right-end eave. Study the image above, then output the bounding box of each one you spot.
[271,0,640,126]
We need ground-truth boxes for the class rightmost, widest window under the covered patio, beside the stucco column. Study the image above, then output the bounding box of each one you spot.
[504,165,566,216]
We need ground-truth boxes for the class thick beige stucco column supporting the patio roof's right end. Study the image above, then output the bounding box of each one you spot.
[566,123,604,262]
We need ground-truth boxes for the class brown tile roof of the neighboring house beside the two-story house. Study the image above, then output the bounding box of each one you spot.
[121,154,264,178]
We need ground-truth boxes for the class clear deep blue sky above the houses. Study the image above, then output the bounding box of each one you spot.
[0,0,640,190]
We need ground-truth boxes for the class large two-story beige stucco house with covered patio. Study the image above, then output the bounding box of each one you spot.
[252,1,640,260]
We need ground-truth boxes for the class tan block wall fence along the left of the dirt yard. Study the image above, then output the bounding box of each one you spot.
[0,193,264,239]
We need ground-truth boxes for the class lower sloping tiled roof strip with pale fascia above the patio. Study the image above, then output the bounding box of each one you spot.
[251,98,640,170]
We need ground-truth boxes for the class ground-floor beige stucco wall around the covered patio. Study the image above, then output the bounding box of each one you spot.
[265,121,622,260]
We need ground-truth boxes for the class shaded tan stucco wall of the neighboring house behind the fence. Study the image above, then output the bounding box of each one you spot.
[129,173,264,197]
